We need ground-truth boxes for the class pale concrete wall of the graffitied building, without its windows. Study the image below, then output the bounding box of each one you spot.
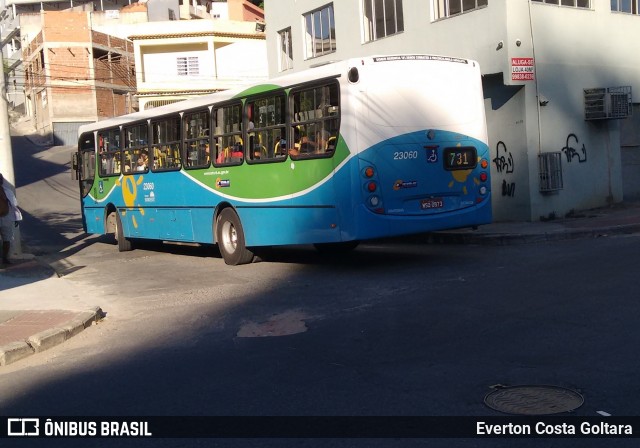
[265,0,640,220]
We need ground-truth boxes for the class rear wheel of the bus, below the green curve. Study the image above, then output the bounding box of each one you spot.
[216,208,253,266]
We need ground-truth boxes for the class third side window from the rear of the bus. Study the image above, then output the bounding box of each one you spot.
[213,103,244,166]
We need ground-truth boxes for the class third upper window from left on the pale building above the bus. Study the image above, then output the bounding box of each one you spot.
[363,0,404,42]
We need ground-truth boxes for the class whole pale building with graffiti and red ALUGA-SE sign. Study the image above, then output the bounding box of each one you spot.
[265,0,640,221]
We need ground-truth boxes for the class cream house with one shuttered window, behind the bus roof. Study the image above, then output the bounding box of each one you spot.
[128,19,268,110]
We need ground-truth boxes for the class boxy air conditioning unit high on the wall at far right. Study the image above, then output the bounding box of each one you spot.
[584,86,633,120]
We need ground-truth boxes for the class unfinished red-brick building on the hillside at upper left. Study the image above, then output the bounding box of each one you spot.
[23,11,136,144]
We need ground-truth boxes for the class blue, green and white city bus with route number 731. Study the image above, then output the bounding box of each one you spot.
[74,55,491,265]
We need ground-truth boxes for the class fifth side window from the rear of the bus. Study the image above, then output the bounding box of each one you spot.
[151,115,182,171]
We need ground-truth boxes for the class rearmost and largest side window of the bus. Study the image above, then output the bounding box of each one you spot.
[288,83,340,159]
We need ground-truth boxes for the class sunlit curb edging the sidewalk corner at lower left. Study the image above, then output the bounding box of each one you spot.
[0,307,105,366]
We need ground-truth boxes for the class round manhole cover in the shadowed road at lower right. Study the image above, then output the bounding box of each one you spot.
[484,386,584,415]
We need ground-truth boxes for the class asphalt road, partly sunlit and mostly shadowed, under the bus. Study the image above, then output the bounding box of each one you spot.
[0,138,640,447]
